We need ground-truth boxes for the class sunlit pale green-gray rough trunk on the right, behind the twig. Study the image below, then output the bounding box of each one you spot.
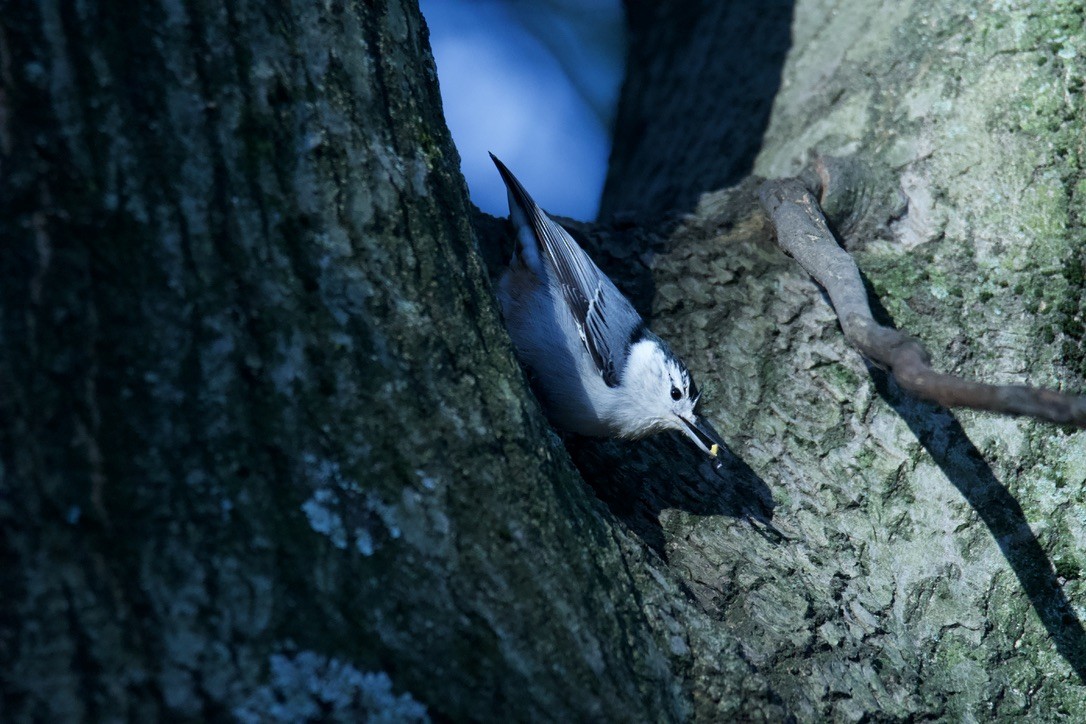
[598,0,1086,721]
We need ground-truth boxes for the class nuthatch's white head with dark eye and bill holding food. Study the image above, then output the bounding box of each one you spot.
[620,331,724,458]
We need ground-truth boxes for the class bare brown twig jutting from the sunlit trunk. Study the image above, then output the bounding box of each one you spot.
[760,178,1086,428]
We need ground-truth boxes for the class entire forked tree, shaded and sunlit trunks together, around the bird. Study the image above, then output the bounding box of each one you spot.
[6,0,1086,721]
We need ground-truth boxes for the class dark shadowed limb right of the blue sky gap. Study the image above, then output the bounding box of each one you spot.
[599,0,795,219]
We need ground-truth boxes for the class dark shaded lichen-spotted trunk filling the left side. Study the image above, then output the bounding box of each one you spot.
[0,1,729,721]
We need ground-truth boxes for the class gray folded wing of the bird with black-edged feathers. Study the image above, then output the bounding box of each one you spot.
[491,154,645,388]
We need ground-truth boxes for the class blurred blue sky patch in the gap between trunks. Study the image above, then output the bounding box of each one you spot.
[420,0,623,220]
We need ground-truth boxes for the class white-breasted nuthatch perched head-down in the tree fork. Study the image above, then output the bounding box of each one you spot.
[490,154,724,469]
